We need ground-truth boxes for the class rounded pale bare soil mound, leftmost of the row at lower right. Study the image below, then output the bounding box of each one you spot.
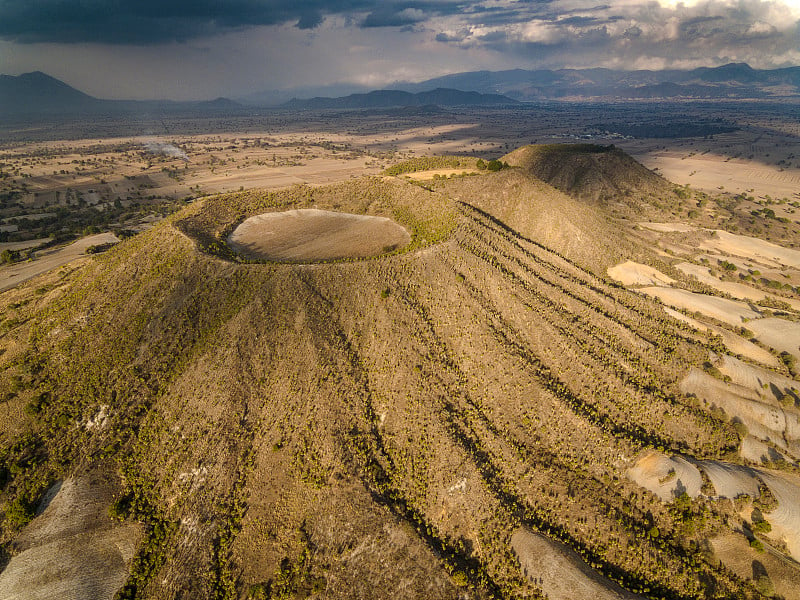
[627,450,703,502]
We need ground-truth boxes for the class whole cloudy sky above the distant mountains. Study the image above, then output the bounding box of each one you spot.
[0,0,800,100]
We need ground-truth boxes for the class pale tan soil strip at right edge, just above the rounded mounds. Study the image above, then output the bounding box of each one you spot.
[681,368,800,458]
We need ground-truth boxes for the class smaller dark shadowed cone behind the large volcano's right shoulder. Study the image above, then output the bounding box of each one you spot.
[502,144,675,201]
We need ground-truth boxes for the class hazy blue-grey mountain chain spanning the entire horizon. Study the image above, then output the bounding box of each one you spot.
[0,63,800,117]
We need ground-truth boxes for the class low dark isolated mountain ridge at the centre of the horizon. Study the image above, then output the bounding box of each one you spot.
[282,87,518,110]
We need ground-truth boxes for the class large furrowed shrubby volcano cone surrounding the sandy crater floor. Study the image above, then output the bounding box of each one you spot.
[0,146,788,599]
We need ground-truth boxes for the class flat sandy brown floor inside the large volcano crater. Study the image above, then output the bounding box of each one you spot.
[228,208,411,262]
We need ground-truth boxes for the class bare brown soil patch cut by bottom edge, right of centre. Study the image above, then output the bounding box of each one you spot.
[511,528,641,600]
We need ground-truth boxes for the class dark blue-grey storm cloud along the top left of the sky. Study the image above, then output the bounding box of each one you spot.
[0,0,466,44]
